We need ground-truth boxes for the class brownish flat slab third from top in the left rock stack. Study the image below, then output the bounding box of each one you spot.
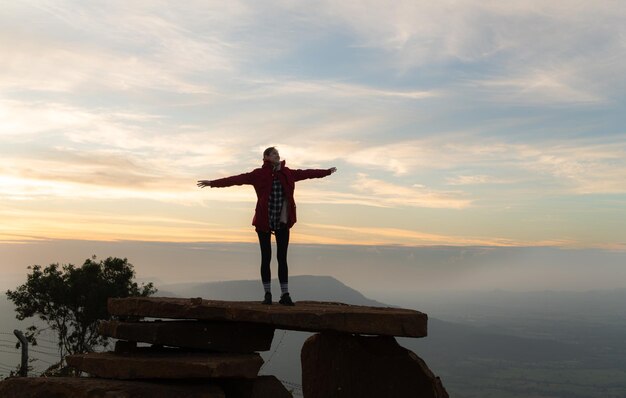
[66,347,263,380]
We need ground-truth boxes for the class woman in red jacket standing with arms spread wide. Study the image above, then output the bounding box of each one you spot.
[198,147,337,305]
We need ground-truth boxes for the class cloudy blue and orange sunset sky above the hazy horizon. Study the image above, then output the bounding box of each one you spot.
[0,0,626,255]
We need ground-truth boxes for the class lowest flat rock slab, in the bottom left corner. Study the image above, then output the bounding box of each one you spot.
[0,377,226,398]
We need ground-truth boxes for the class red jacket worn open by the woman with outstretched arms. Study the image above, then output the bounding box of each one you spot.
[211,160,330,232]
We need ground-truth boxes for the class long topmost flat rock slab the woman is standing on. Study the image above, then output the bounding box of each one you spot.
[108,297,428,337]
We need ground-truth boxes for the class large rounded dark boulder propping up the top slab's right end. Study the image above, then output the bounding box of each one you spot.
[301,333,448,398]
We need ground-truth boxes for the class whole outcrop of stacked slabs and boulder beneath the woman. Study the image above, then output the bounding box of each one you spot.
[0,297,447,398]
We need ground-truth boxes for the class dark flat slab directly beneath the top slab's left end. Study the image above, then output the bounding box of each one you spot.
[98,321,274,353]
